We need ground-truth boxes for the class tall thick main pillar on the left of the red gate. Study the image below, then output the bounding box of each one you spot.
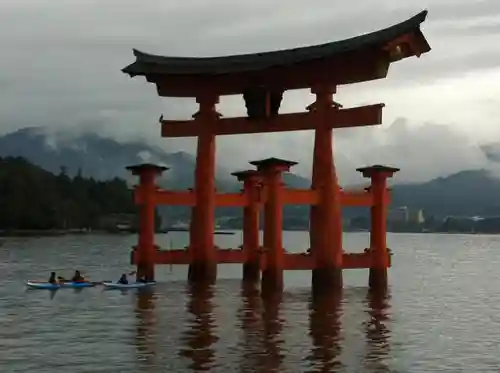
[188,95,220,282]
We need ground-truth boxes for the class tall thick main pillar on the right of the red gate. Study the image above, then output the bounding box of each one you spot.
[308,87,342,291]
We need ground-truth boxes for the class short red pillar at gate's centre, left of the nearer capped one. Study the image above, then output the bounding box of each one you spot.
[232,170,262,282]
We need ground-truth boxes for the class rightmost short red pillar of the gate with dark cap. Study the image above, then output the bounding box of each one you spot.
[357,165,399,290]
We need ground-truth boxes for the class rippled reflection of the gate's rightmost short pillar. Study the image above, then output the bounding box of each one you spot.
[364,291,391,373]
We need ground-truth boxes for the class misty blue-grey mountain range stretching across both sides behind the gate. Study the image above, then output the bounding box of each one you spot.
[0,127,500,219]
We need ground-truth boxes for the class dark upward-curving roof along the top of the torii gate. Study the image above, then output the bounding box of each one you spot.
[122,10,430,76]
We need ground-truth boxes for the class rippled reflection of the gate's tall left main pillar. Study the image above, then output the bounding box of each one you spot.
[179,283,218,372]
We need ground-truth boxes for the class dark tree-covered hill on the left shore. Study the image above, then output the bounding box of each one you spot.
[0,157,137,230]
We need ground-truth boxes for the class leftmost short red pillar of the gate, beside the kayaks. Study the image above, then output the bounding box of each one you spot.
[127,163,167,281]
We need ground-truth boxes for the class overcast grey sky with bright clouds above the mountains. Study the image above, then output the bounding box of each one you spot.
[0,0,500,183]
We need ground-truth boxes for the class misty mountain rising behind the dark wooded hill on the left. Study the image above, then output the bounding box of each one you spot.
[0,127,309,190]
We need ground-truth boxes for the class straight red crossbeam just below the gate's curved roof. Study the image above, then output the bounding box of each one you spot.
[160,104,384,137]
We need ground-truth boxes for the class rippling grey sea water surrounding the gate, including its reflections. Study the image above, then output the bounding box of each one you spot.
[0,235,500,373]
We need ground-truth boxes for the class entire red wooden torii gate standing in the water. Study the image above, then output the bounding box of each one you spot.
[123,11,430,288]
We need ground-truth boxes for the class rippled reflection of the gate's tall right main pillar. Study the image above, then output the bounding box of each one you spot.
[307,291,343,372]
